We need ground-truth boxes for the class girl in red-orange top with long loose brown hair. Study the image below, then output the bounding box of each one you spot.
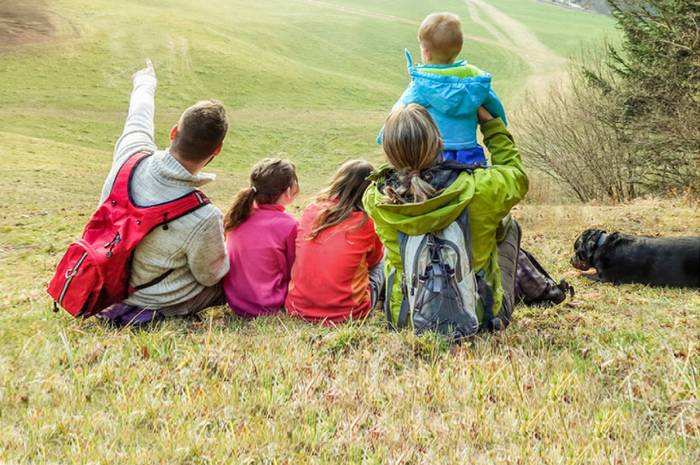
[285,160,384,323]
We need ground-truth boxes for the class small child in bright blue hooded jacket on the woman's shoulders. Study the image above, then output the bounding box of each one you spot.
[378,13,506,165]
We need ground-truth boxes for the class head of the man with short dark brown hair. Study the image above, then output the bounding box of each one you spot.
[170,100,228,162]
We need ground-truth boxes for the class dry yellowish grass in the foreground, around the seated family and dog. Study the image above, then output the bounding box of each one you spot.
[0,133,700,464]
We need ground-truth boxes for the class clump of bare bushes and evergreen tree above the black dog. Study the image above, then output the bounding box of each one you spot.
[521,0,700,201]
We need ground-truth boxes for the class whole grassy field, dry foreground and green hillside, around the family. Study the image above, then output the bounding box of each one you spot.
[0,0,700,464]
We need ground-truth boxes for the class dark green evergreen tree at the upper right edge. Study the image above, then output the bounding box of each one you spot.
[587,0,700,192]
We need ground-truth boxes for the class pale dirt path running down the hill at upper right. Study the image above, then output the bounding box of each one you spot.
[464,0,567,99]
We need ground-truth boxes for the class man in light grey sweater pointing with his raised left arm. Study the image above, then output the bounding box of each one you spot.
[100,60,229,324]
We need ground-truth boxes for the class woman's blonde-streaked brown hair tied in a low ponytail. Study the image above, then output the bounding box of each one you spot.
[382,103,442,203]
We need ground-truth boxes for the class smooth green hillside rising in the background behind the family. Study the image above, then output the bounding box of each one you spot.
[0,0,612,184]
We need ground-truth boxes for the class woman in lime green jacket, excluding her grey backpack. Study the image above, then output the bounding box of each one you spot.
[363,104,528,329]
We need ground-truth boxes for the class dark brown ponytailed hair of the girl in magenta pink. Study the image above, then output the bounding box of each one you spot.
[224,158,299,231]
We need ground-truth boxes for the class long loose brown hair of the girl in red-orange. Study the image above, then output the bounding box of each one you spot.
[309,160,374,239]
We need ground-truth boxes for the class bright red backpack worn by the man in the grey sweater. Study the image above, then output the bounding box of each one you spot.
[48,152,209,317]
